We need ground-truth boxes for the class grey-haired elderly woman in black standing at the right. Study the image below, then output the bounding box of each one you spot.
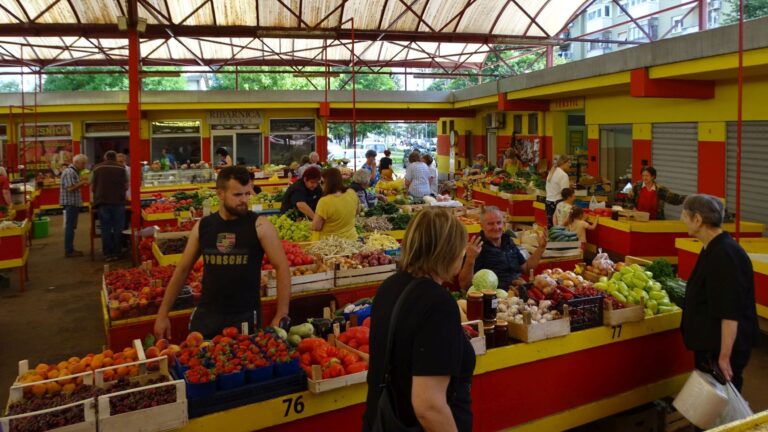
[680,194,759,391]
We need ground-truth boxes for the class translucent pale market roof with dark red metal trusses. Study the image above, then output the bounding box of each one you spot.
[0,0,593,72]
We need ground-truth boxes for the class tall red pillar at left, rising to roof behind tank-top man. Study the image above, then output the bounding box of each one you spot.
[128,28,142,231]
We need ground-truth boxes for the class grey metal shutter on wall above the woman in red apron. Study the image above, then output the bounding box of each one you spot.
[651,123,699,220]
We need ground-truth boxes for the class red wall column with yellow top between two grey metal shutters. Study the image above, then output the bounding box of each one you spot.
[698,122,726,198]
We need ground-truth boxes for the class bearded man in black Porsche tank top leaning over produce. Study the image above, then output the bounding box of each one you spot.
[155,166,291,339]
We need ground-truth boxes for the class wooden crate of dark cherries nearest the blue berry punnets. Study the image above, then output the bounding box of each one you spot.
[98,380,189,432]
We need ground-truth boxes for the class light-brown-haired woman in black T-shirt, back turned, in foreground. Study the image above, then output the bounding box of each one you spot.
[363,207,475,431]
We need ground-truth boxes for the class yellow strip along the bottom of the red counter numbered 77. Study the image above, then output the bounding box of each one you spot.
[507,373,689,432]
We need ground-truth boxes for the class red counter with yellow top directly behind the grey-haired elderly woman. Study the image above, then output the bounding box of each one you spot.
[675,238,768,319]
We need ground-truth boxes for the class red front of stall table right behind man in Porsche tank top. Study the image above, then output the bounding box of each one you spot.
[99,283,380,350]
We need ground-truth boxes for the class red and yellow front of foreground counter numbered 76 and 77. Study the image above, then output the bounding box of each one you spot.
[182,313,693,432]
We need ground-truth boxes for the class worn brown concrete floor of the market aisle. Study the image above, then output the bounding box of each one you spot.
[0,213,768,422]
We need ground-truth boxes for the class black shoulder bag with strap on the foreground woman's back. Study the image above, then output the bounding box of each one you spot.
[372,278,423,432]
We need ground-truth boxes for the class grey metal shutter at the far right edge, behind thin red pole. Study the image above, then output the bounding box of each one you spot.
[725,122,768,230]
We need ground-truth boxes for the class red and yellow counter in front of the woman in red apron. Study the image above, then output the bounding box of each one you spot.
[587,221,765,264]
